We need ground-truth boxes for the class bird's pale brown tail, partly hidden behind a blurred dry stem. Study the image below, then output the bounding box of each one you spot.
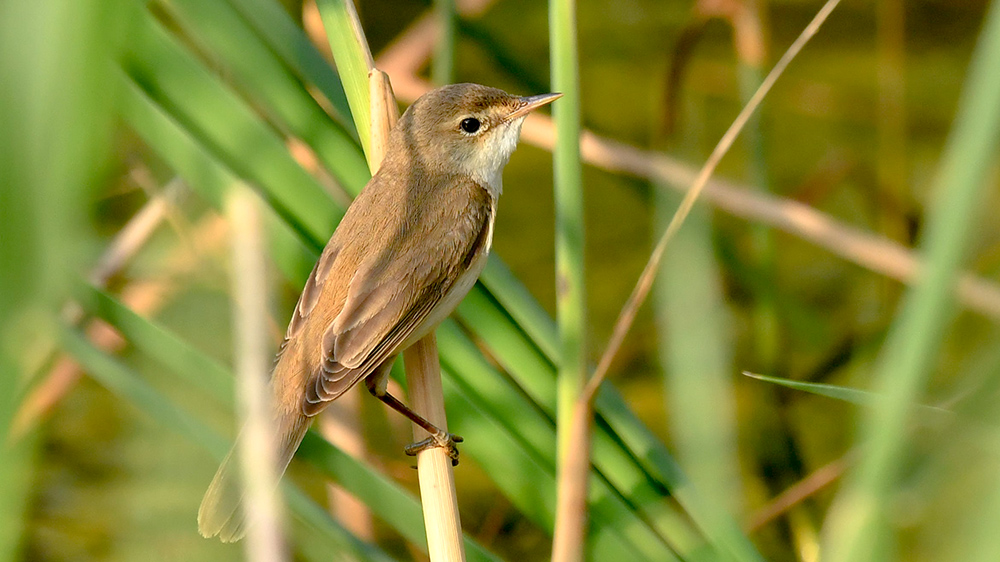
[198,414,311,542]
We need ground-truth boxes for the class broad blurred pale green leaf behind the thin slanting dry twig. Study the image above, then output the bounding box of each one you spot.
[658,191,743,532]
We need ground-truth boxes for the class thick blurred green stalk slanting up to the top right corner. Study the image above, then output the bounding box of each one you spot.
[823,2,1000,562]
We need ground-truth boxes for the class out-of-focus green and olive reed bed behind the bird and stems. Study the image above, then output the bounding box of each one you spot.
[0,0,1000,561]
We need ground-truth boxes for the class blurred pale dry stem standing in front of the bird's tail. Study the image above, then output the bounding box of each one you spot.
[226,188,287,562]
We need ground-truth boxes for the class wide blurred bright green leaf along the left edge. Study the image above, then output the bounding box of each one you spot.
[0,0,122,560]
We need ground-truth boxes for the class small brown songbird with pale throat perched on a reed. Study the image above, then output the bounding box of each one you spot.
[198,84,561,542]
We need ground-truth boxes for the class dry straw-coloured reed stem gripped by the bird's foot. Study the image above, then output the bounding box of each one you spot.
[368,69,465,562]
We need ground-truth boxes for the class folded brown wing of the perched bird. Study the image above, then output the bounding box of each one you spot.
[293,179,492,416]
